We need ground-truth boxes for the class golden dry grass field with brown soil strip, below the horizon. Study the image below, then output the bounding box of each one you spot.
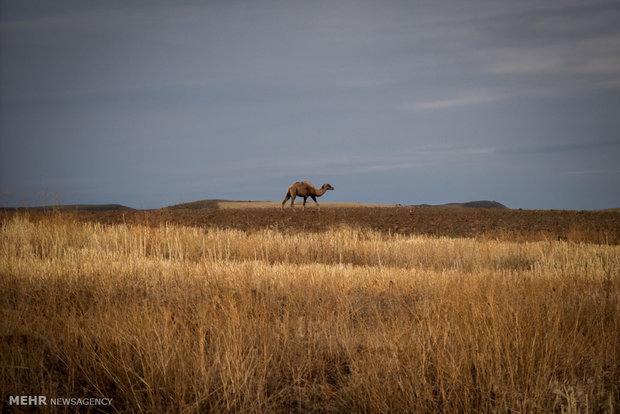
[0,208,620,413]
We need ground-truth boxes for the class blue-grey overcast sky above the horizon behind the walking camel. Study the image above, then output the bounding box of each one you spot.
[0,0,620,209]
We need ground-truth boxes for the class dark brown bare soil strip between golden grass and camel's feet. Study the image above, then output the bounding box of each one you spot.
[8,207,620,245]
